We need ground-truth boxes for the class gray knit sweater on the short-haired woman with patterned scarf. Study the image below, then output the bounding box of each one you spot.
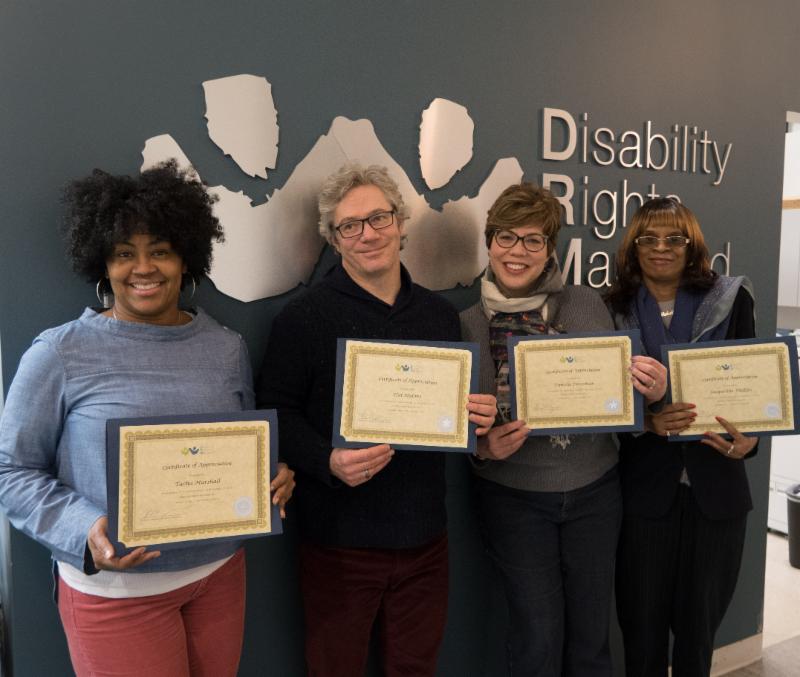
[460,286,617,491]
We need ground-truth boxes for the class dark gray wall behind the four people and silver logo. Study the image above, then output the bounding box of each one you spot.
[0,0,800,676]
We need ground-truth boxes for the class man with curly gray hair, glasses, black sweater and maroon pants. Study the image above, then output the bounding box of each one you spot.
[257,164,496,677]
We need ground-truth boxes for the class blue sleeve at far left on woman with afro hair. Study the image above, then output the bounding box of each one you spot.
[0,340,105,570]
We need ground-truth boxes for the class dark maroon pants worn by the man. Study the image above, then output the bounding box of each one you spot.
[300,536,448,677]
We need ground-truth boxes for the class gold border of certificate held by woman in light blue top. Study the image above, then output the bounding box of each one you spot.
[117,421,272,545]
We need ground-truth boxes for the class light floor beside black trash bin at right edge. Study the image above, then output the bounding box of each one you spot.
[727,533,800,677]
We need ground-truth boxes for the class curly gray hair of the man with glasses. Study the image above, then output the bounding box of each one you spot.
[317,162,409,245]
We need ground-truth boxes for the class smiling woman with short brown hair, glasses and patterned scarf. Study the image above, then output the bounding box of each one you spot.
[461,183,666,677]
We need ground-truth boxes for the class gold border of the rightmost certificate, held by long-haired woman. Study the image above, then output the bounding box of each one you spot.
[669,343,794,435]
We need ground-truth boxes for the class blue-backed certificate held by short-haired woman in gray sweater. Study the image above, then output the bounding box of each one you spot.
[508,330,644,435]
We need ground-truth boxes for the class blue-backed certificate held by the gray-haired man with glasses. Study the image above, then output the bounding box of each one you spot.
[333,339,478,453]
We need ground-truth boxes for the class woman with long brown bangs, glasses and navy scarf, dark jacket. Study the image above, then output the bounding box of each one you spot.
[607,198,756,677]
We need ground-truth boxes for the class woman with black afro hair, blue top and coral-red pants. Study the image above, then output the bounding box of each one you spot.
[0,161,294,677]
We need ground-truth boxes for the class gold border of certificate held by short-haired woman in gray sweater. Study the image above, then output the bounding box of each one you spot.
[514,336,636,428]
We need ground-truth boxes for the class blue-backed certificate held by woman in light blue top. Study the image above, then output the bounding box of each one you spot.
[106,410,282,550]
